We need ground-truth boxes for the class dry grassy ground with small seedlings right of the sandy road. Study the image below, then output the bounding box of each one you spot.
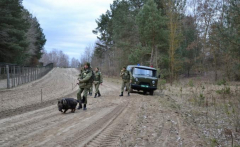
[159,78,240,147]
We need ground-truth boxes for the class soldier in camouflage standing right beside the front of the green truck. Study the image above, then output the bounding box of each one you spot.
[119,67,132,96]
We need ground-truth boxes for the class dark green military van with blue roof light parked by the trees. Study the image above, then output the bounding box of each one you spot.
[127,65,160,95]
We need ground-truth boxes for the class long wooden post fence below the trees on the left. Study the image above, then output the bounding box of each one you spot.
[0,63,53,89]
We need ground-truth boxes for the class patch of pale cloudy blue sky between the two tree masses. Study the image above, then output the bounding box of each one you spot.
[23,0,113,59]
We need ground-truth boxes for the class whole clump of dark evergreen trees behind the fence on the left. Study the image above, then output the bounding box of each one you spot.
[0,0,46,66]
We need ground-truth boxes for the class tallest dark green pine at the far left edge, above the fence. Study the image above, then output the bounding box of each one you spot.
[0,0,29,64]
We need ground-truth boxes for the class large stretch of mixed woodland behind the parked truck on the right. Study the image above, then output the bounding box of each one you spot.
[91,0,240,82]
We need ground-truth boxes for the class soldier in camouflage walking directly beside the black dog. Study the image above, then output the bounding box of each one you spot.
[77,63,92,110]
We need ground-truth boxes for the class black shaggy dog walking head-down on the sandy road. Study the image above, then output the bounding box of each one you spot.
[58,98,78,113]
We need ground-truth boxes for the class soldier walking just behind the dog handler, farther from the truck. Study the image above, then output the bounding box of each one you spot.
[93,67,103,98]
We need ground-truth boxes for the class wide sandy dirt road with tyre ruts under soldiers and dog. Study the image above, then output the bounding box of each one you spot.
[0,68,206,147]
